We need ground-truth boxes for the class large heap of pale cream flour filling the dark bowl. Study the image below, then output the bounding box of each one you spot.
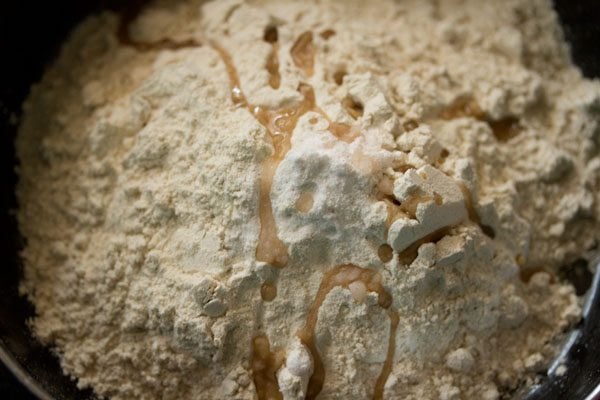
[17,0,600,400]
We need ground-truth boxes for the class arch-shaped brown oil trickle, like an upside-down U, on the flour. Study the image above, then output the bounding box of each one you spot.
[298,264,399,400]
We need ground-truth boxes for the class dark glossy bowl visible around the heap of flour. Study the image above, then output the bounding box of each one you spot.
[0,0,600,400]
